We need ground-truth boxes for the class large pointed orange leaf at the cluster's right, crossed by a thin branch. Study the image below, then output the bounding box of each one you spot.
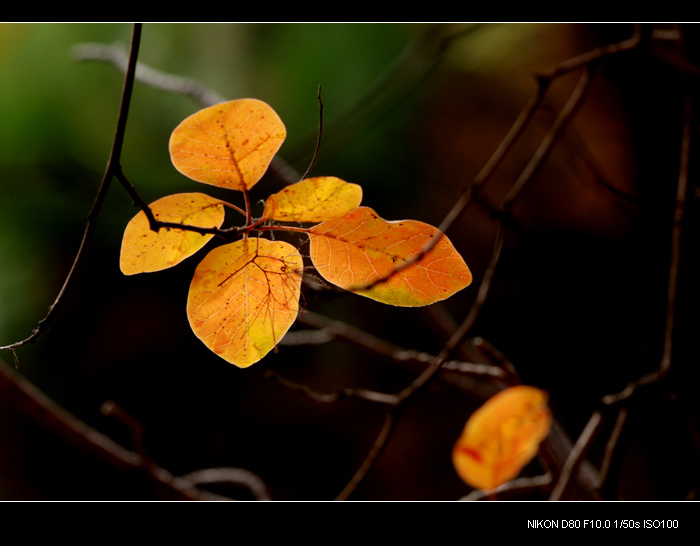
[309,207,472,307]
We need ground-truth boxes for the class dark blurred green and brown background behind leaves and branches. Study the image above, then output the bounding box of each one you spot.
[0,23,700,500]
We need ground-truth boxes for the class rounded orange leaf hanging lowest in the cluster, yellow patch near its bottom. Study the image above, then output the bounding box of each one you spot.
[187,238,303,368]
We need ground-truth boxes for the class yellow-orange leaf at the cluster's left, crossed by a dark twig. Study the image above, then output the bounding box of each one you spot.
[119,193,224,275]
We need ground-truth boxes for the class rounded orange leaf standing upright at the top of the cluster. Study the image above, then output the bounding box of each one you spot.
[170,99,287,191]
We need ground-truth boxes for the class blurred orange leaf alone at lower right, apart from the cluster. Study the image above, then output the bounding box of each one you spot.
[452,385,552,491]
